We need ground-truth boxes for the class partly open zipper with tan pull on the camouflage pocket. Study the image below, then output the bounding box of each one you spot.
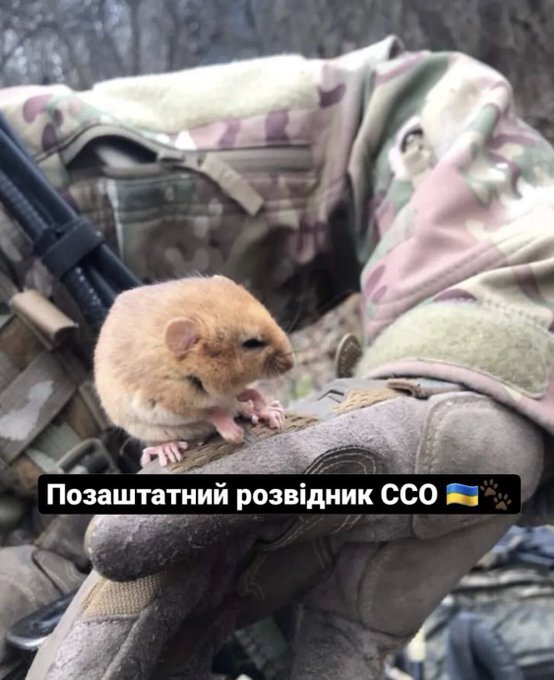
[58,125,313,215]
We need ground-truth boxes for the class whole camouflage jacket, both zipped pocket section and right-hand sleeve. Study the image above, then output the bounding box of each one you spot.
[0,37,554,446]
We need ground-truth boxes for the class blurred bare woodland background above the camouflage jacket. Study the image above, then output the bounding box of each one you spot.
[0,0,554,141]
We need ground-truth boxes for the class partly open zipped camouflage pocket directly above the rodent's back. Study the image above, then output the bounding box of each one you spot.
[59,125,328,328]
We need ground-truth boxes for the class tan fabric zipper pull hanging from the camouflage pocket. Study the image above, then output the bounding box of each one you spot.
[158,149,264,216]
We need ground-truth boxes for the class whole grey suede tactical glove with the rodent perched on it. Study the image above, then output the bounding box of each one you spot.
[28,379,544,680]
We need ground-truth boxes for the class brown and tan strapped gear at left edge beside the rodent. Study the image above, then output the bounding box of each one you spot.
[0,276,115,496]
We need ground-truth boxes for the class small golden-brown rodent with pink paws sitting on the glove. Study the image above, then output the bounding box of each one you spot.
[94,276,294,465]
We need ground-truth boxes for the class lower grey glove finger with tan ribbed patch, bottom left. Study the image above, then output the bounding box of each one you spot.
[27,569,213,680]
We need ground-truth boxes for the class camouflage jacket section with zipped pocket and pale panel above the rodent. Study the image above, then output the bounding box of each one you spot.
[0,37,401,328]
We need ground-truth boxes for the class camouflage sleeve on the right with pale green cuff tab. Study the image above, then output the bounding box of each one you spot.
[351,52,554,432]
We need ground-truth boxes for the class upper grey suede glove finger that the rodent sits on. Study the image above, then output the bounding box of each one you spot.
[86,386,414,580]
